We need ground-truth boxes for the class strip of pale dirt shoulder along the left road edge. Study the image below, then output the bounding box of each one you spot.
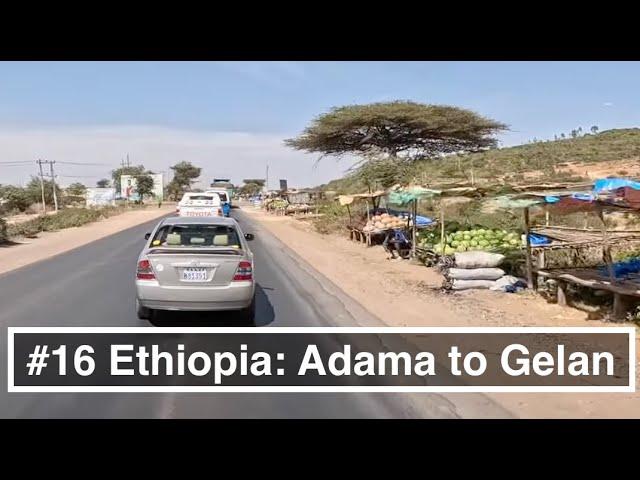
[0,205,175,274]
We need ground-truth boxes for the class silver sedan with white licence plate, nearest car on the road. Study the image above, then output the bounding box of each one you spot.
[136,217,255,324]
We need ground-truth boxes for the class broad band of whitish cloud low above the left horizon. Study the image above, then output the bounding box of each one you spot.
[0,126,351,188]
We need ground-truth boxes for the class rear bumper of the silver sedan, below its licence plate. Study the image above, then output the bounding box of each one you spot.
[136,280,255,310]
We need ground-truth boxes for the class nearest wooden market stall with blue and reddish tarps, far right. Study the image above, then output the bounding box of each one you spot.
[493,178,640,318]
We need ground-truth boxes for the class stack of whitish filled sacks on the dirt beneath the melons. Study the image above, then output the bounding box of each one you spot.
[443,251,524,292]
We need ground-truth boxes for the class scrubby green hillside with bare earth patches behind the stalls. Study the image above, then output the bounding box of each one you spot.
[323,128,640,193]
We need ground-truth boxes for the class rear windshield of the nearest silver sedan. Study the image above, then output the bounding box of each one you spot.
[151,224,241,248]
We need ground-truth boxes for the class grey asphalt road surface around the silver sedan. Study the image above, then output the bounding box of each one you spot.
[0,209,508,418]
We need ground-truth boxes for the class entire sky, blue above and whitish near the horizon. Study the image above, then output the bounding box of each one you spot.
[0,62,640,186]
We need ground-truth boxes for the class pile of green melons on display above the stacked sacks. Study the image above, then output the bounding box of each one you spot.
[419,228,522,255]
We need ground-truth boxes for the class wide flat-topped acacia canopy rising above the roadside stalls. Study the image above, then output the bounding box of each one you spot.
[285,101,507,158]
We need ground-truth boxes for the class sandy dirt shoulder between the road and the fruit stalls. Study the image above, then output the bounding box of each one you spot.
[243,206,640,418]
